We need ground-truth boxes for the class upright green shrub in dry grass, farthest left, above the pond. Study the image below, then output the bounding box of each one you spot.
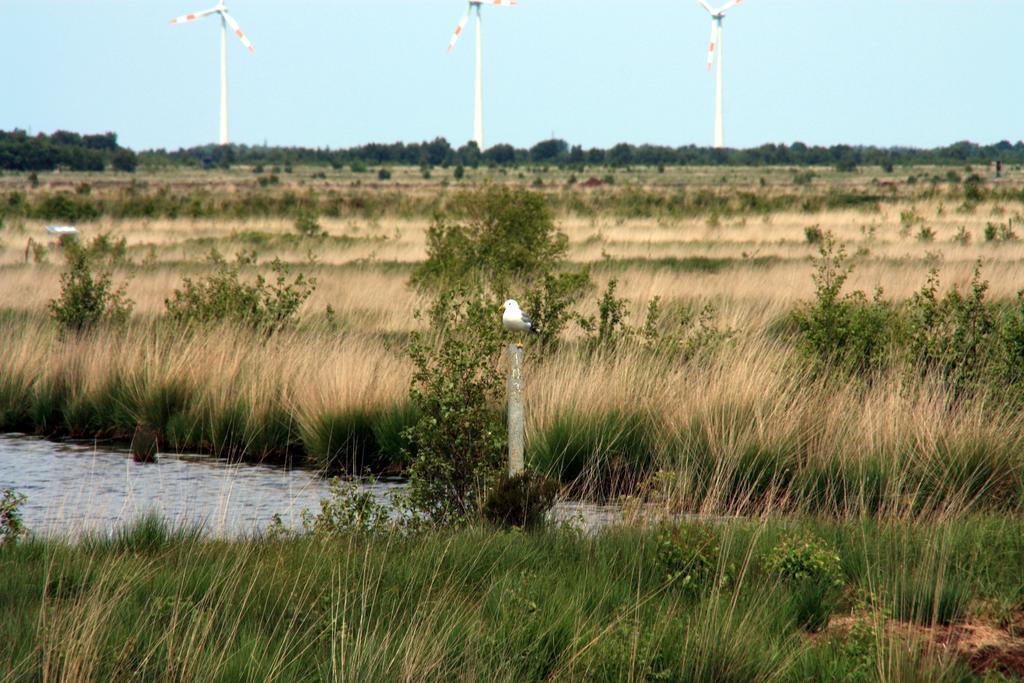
[49,242,134,334]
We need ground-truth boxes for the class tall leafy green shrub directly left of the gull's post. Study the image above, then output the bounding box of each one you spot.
[403,293,506,525]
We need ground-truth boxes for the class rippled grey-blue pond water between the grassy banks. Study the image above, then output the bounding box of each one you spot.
[0,435,622,537]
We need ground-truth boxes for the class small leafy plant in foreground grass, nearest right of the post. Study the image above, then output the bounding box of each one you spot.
[657,524,722,593]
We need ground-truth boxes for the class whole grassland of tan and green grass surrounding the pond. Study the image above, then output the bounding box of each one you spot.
[0,166,1024,681]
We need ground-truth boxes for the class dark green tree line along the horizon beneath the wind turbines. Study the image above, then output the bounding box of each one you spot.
[0,130,1024,171]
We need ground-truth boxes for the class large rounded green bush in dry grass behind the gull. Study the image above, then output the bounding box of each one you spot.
[412,186,567,291]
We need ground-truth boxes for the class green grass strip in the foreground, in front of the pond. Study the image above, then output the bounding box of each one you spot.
[0,516,1024,682]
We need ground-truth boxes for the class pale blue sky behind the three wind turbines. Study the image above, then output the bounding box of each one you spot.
[0,0,1024,148]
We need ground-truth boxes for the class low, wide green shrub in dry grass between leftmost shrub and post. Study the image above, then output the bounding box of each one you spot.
[164,251,316,332]
